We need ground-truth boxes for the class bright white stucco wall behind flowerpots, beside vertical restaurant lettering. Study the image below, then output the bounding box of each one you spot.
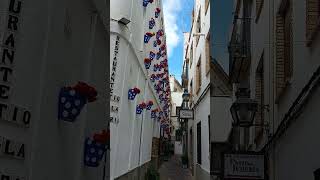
[110,0,168,179]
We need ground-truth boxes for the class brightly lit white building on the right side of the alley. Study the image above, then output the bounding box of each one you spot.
[182,0,210,179]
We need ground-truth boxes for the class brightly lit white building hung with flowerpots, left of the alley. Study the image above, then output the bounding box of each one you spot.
[110,0,170,179]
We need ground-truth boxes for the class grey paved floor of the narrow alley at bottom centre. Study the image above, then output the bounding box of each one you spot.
[159,156,192,180]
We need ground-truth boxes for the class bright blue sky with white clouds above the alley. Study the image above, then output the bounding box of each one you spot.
[163,0,182,57]
